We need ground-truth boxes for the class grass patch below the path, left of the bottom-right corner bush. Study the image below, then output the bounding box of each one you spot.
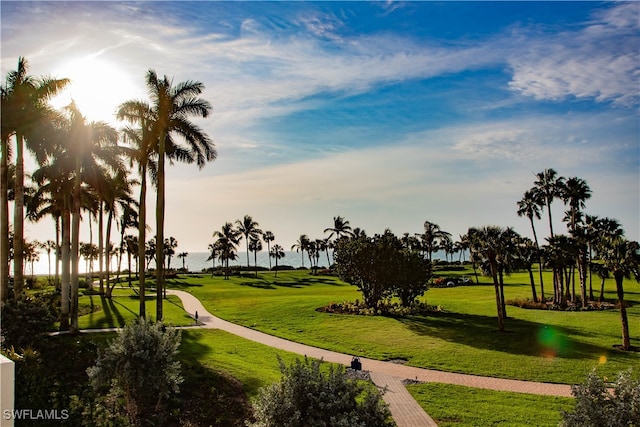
[407,383,574,427]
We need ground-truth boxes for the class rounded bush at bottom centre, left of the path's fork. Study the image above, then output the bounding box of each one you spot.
[249,358,394,427]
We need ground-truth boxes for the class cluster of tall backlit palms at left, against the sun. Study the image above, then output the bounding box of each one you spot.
[0,58,216,332]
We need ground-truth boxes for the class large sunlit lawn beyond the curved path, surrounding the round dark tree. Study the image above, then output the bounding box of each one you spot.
[169,271,640,383]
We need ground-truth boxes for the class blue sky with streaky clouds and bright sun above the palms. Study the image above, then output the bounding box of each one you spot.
[0,1,640,252]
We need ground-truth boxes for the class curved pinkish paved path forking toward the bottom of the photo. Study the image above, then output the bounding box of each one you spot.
[167,290,571,427]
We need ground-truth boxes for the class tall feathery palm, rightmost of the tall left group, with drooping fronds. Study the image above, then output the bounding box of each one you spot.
[141,70,217,321]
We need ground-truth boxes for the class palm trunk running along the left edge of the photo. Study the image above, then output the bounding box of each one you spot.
[0,138,9,302]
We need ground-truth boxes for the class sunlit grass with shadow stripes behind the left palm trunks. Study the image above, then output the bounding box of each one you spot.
[78,288,193,329]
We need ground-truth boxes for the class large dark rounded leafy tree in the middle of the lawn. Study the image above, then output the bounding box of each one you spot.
[334,231,431,308]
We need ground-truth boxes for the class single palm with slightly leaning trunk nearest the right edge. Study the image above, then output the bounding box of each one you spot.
[600,236,640,350]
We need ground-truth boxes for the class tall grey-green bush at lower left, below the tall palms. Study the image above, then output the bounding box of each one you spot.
[87,319,182,424]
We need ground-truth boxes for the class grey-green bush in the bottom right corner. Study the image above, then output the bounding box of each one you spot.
[560,369,640,427]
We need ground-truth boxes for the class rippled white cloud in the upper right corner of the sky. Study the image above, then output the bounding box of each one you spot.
[508,2,640,106]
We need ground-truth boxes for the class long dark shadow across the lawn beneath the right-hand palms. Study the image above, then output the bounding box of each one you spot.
[397,312,612,360]
